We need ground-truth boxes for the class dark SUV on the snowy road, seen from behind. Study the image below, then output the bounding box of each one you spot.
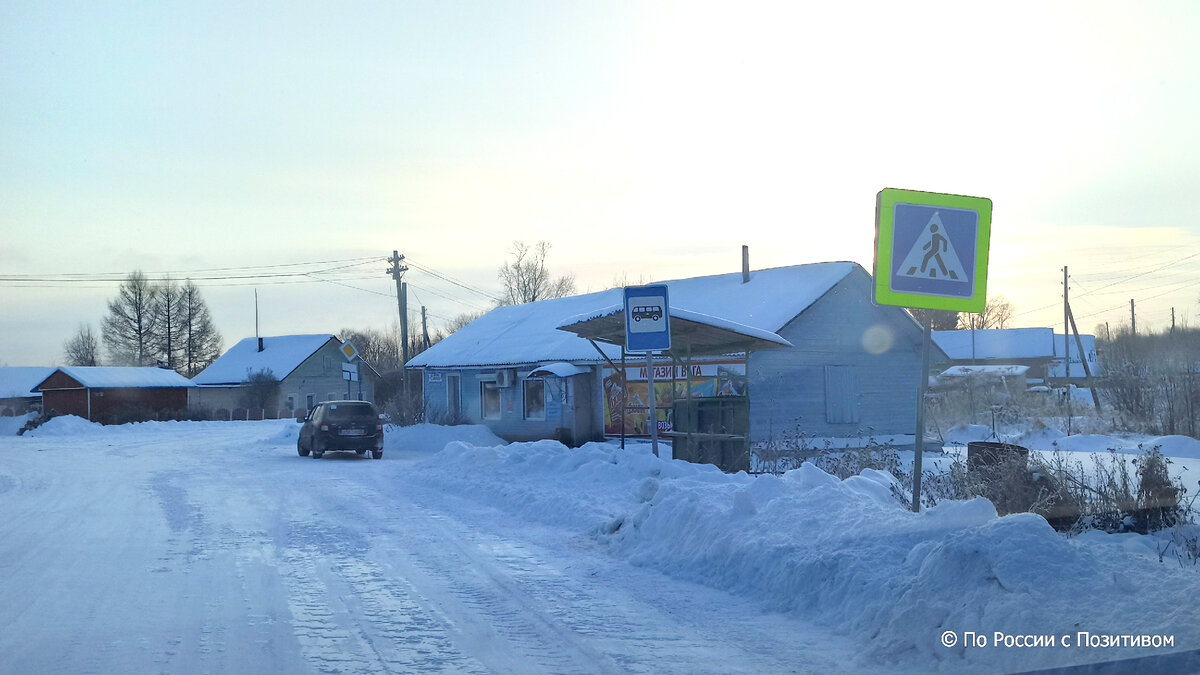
[296,401,383,459]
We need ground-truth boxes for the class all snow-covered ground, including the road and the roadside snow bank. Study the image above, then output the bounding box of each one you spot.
[0,418,1200,673]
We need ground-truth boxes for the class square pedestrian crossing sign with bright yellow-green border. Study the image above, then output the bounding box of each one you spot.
[875,187,991,312]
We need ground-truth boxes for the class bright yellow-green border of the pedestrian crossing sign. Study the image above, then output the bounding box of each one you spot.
[872,187,991,313]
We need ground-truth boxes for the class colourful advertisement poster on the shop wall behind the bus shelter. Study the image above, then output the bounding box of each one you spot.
[604,360,746,436]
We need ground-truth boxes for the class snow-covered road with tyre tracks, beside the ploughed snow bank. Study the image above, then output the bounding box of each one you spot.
[0,422,859,673]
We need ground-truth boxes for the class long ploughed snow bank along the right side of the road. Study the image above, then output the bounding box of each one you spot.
[414,430,1200,670]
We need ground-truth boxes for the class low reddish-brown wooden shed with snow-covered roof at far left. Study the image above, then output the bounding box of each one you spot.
[36,366,194,424]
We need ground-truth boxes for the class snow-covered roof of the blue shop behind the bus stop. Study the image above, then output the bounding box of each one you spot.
[408,263,866,368]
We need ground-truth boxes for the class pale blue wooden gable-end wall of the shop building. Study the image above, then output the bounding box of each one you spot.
[748,270,922,443]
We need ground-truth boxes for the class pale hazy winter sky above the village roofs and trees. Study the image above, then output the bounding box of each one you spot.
[0,1,1200,365]
